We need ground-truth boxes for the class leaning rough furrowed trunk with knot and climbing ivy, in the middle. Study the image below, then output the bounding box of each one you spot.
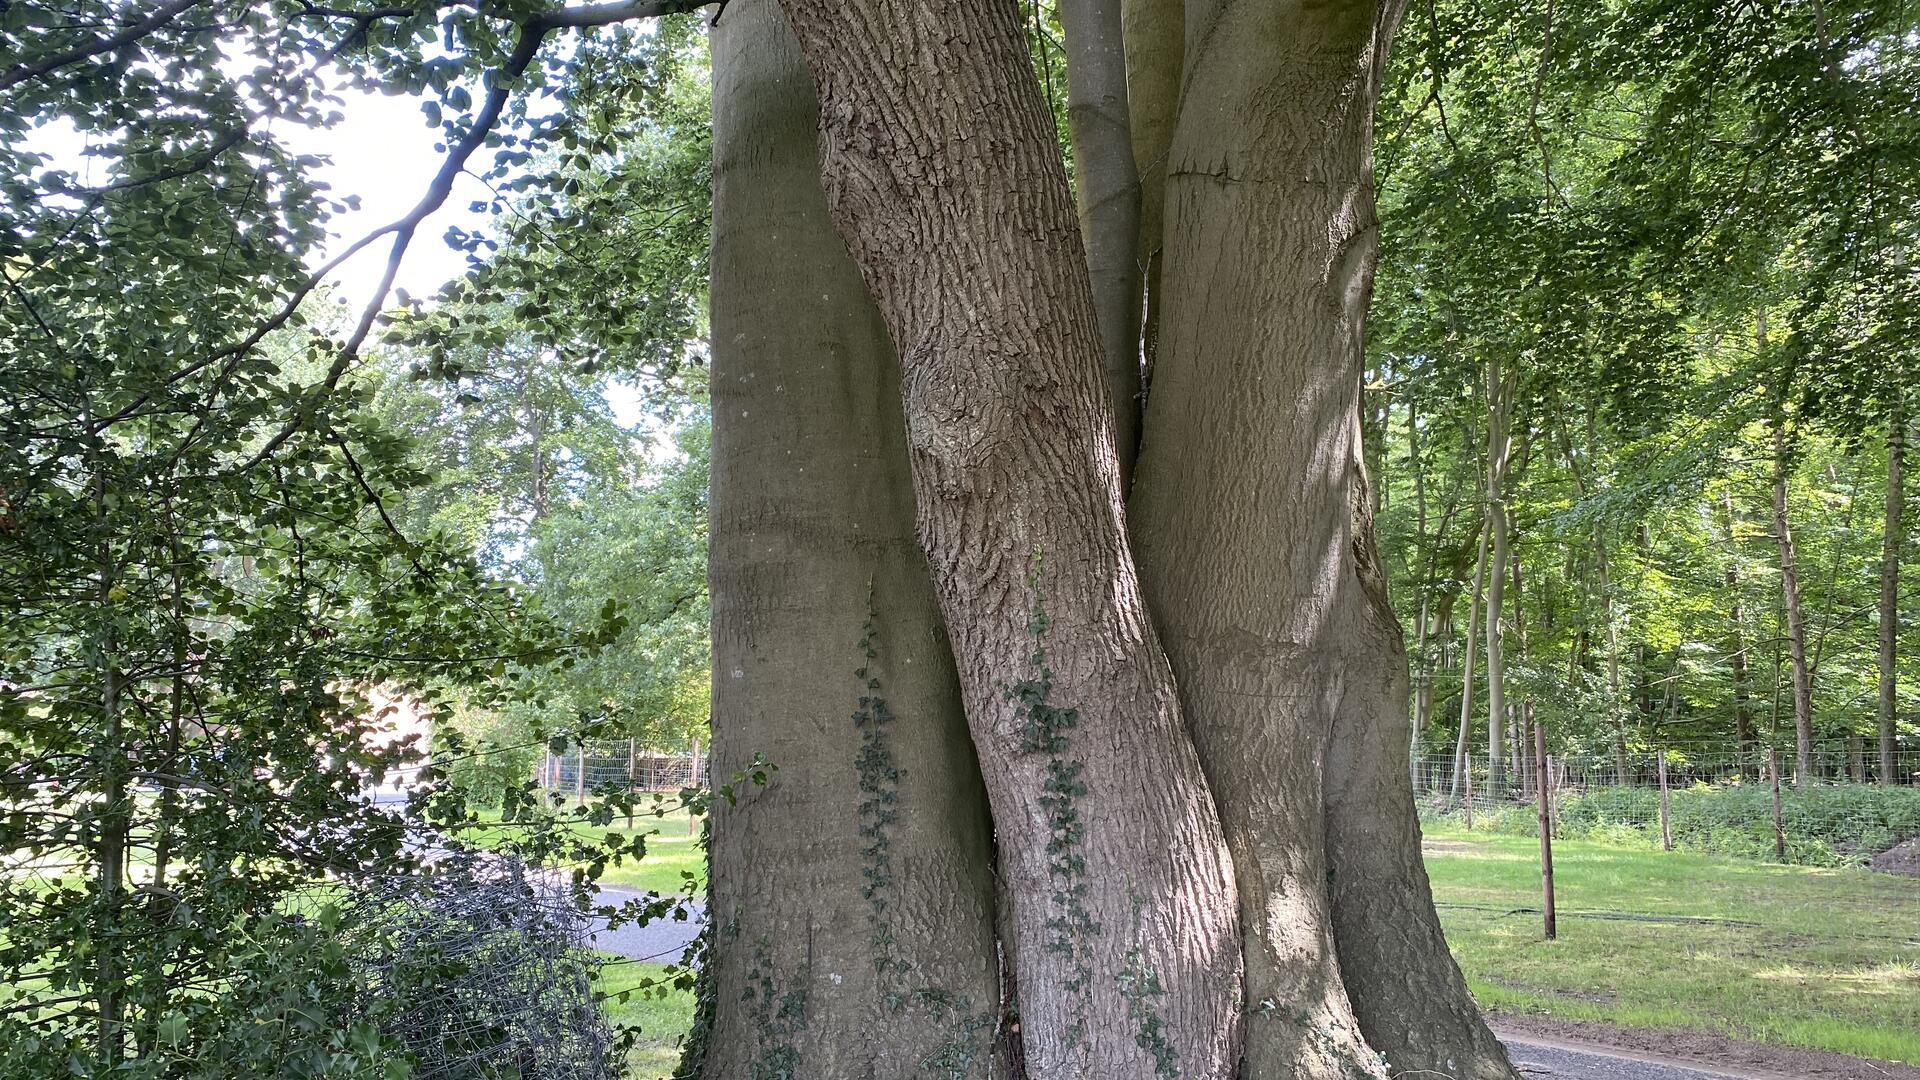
[768,0,1238,1080]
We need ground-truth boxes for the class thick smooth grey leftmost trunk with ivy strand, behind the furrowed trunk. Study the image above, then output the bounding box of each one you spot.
[701,0,1004,1080]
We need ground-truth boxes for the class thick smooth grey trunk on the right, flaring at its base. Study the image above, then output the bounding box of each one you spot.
[1131,2,1511,1078]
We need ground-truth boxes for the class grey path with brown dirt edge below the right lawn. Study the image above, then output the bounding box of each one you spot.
[1488,1015,1920,1080]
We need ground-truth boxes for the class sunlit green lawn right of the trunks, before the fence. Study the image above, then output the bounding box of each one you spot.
[1427,828,1920,1065]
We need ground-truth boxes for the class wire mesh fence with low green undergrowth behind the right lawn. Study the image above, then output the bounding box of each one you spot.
[1411,740,1920,867]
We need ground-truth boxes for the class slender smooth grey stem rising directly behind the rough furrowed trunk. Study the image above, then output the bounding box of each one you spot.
[1054,0,1140,480]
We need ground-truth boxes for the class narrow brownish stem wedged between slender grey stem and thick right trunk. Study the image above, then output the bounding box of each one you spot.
[1121,0,1187,392]
